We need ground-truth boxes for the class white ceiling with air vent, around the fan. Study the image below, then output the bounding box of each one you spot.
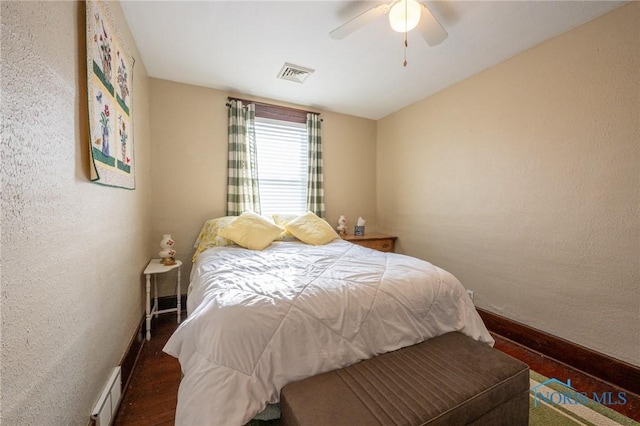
[121,0,625,119]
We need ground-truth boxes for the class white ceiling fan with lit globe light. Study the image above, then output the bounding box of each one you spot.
[329,0,448,46]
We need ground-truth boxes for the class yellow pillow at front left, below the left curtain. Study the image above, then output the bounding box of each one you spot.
[220,212,283,250]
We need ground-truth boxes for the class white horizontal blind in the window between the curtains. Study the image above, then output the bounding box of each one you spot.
[255,117,308,215]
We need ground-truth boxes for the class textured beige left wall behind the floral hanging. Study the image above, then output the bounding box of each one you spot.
[0,1,151,425]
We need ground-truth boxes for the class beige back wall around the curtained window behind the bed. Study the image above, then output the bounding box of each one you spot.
[150,78,376,294]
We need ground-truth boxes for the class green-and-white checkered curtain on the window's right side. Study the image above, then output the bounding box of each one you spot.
[307,114,324,218]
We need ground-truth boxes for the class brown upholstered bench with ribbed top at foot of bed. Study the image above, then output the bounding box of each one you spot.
[280,332,529,426]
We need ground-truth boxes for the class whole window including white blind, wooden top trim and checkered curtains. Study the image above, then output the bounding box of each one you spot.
[227,97,325,217]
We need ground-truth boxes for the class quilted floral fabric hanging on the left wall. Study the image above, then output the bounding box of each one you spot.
[86,0,135,189]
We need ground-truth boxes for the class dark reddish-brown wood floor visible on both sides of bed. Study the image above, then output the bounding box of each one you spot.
[114,314,640,426]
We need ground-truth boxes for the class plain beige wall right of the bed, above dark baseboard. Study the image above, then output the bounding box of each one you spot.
[377,2,640,365]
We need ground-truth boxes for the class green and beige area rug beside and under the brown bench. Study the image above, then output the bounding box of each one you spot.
[246,371,640,426]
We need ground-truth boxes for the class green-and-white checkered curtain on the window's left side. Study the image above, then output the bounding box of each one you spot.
[227,100,260,216]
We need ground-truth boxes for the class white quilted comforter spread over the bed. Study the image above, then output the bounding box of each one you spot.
[164,240,493,425]
